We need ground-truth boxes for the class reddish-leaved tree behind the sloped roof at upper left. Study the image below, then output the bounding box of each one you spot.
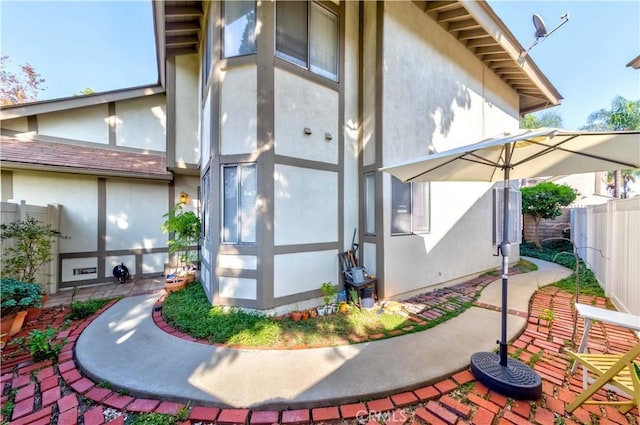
[0,55,44,106]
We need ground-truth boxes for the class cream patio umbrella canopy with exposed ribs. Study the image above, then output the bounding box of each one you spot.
[381,128,640,182]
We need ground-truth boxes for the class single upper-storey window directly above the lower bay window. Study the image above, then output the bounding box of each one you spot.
[222,1,256,58]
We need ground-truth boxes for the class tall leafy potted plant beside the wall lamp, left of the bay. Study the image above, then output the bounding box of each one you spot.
[162,202,201,291]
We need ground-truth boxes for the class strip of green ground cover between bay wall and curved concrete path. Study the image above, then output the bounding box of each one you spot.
[162,261,536,349]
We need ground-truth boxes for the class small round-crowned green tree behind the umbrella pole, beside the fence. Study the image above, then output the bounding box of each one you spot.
[520,182,578,249]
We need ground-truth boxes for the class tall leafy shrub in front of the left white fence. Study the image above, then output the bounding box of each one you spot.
[0,216,67,314]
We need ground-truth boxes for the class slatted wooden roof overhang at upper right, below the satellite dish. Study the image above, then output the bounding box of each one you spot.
[415,0,562,114]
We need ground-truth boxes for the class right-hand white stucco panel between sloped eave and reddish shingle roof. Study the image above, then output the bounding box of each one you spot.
[116,94,167,152]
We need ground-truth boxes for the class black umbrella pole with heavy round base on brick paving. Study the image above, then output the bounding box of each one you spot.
[471,155,542,400]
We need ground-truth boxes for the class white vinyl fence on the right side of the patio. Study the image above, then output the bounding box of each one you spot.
[571,197,640,315]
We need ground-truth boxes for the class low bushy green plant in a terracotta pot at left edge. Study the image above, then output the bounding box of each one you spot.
[0,277,42,336]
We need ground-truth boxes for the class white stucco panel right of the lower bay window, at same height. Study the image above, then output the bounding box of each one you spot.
[274,165,338,245]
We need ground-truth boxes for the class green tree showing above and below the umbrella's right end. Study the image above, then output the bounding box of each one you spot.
[582,96,640,198]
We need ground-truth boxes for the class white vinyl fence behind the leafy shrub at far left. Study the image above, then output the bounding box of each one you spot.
[0,201,62,294]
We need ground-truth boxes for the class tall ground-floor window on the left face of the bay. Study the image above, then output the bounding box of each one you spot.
[222,164,257,244]
